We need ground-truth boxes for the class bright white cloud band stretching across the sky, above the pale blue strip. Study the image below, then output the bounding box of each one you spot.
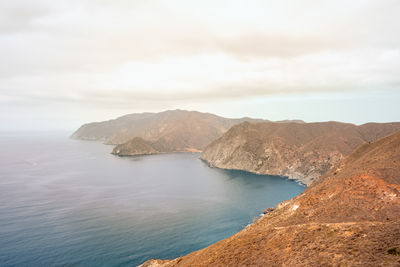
[1,49,400,106]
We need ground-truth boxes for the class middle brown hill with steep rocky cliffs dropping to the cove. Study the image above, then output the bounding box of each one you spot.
[201,122,400,185]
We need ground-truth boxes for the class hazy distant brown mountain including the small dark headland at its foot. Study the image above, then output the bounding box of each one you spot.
[71,110,304,155]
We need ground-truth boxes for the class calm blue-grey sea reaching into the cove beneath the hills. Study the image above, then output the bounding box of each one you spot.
[0,134,304,266]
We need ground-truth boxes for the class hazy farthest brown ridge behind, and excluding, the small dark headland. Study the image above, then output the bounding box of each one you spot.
[71,110,268,145]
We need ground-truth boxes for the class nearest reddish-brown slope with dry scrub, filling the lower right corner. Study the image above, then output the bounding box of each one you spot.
[143,129,400,266]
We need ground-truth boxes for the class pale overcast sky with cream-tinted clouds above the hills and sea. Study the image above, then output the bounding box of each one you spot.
[0,0,400,131]
